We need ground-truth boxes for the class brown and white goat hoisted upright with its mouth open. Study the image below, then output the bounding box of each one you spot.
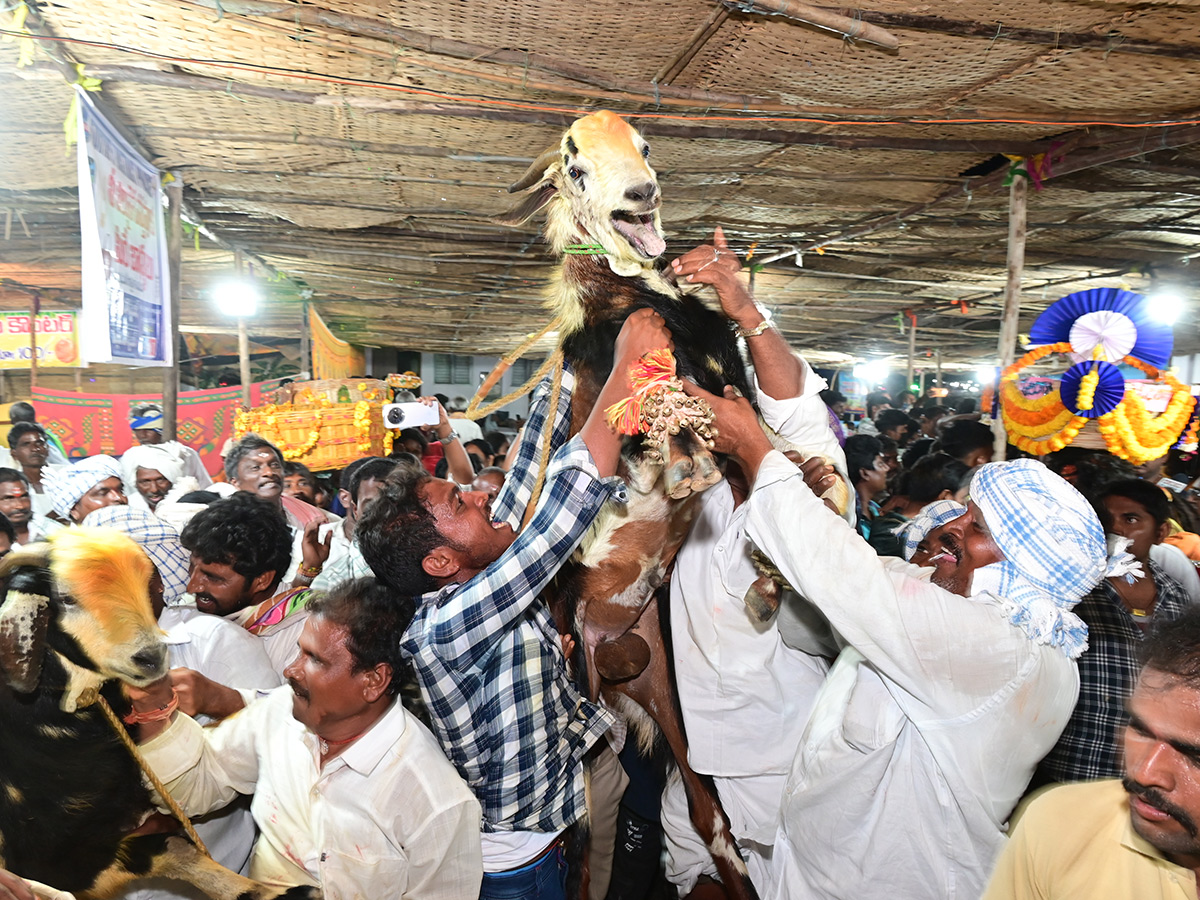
[500,112,756,900]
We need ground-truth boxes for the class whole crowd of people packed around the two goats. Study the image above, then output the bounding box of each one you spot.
[0,256,1200,900]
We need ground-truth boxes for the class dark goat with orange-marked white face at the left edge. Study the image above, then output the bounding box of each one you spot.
[0,528,320,900]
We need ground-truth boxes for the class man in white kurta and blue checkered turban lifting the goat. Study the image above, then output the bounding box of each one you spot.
[694,391,1108,900]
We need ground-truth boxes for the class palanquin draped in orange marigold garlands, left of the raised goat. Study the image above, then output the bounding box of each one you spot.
[233,372,421,472]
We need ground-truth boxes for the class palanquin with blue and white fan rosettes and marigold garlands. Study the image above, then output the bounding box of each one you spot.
[985,288,1196,464]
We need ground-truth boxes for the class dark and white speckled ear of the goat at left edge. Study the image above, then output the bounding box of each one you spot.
[0,544,50,694]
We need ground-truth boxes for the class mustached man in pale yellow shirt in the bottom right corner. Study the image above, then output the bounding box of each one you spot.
[984,606,1200,900]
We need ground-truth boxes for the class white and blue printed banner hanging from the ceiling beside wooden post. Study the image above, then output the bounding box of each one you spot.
[76,86,175,366]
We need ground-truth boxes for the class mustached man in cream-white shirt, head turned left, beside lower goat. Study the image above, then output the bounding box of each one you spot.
[133,578,482,900]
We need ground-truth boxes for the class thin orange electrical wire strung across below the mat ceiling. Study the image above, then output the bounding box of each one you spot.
[7,29,1200,128]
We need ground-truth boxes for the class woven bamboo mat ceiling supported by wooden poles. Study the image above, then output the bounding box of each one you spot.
[0,0,1200,364]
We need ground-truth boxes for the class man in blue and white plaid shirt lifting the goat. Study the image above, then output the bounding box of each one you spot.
[359,310,671,898]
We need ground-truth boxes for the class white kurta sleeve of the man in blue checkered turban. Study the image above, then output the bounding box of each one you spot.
[746,452,1033,719]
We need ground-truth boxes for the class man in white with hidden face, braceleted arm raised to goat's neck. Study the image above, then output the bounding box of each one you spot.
[662,236,854,895]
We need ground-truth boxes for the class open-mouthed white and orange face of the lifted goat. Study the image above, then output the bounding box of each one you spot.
[550,110,666,268]
